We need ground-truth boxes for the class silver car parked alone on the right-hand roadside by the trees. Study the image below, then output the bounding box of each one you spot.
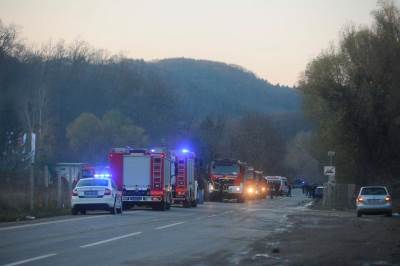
[356,186,393,217]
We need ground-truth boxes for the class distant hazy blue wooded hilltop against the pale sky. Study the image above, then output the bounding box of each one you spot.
[152,58,301,117]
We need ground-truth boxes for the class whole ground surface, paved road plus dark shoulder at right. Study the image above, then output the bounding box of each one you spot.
[0,190,400,266]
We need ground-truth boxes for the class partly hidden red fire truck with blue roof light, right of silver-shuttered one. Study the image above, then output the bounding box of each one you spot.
[172,149,197,208]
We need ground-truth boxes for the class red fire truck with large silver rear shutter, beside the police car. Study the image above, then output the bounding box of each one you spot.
[109,148,173,210]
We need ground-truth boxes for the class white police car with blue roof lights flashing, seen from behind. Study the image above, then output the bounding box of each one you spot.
[71,178,122,215]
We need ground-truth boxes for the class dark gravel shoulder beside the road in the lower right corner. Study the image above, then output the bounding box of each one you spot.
[244,210,400,266]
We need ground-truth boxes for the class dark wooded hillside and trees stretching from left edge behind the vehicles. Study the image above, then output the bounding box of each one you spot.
[0,19,320,183]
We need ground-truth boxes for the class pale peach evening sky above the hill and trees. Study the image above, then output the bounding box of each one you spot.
[0,0,390,85]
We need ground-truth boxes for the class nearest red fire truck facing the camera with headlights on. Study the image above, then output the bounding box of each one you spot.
[208,159,245,202]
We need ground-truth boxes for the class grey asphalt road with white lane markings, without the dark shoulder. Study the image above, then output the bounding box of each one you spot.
[0,191,306,266]
